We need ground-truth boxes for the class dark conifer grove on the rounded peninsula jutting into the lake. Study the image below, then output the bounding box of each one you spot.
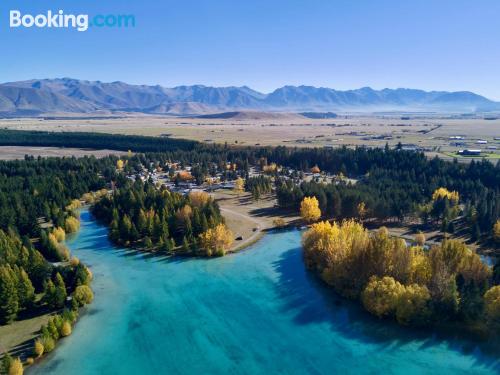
[91,179,232,256]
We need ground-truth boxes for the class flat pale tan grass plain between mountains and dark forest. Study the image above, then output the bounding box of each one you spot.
[0,115,500,161]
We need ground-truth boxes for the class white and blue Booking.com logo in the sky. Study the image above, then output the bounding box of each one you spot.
[9,10,135,31]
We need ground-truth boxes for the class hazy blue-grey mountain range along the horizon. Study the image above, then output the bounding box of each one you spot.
[0,78,500,116]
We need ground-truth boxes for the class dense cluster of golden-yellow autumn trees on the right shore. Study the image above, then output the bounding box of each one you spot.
[303,220,500,332]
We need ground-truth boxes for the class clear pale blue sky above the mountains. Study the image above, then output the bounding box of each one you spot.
[0,0,500,100]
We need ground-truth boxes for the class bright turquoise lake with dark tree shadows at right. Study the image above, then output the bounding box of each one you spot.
[28,211,500,375]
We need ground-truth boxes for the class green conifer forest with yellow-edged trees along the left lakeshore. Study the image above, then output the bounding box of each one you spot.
[0,157,109,369]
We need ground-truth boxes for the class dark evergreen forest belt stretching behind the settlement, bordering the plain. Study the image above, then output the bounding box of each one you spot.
[0,130,500,241]
